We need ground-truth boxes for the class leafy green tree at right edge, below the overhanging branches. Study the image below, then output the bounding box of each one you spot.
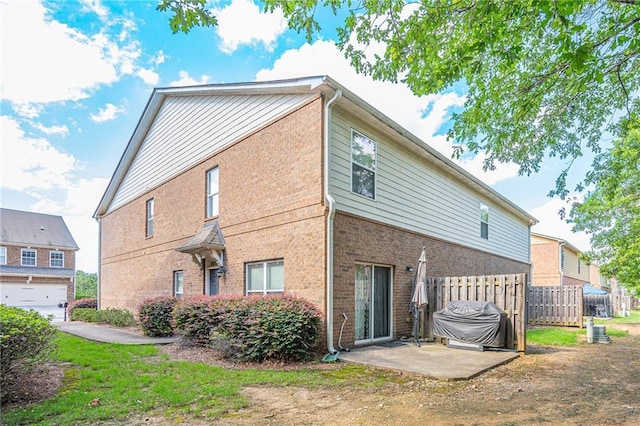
[570,121,640,292]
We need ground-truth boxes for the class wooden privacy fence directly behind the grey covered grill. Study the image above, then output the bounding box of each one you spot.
[425,274,527,352]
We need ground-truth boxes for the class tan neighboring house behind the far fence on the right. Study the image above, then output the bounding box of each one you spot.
[531,232,589,286]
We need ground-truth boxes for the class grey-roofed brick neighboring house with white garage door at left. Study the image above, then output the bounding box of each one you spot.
[0,209,78,307]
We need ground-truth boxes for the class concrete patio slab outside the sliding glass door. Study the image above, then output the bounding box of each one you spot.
[338,342,520,380]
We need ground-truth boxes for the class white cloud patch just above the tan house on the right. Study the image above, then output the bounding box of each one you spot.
[529,198,591,251]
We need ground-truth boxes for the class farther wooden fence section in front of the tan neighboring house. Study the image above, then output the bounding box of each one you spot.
[527,285,583,328]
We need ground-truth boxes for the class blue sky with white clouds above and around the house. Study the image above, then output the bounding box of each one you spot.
[0,0,588,272]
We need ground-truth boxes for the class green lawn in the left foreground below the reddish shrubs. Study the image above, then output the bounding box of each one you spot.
[2,333,390,425]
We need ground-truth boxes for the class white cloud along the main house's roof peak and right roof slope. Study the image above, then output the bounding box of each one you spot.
[256,41,518,185]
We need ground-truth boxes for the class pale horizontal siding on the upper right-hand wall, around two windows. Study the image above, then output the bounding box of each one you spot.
[329,108,529,262]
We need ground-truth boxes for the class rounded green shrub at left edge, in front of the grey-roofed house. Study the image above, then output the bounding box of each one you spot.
[0,305,57,400]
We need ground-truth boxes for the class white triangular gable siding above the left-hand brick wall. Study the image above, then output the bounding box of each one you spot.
[109,93,318,211]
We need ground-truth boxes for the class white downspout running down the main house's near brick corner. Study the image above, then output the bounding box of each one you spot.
[324,89,342,354]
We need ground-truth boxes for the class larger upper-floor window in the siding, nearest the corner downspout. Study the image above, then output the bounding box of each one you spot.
[351,130,377,199]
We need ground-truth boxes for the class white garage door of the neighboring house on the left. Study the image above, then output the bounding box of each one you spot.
[0,283,67,306]
